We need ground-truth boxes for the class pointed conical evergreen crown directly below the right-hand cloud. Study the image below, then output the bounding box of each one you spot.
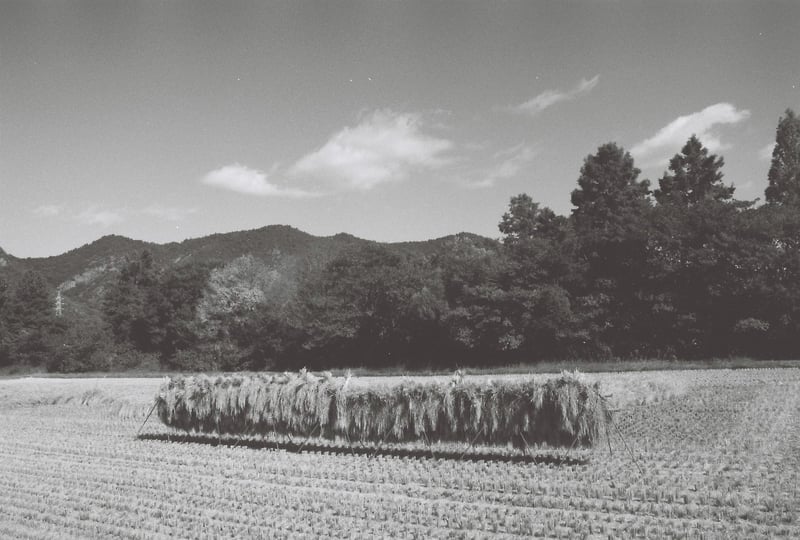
[653,135,734,206]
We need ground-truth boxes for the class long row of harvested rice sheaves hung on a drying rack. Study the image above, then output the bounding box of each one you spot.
[156,371,611,447]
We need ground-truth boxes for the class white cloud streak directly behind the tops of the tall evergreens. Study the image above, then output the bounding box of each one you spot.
[631,103,750,166]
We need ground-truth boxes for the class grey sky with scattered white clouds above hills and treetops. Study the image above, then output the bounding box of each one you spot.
[0,0,800,257]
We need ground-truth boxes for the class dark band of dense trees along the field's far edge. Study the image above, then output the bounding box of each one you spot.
[0,109,800,372]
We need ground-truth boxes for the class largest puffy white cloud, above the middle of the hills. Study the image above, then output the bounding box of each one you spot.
[288,110,453,190]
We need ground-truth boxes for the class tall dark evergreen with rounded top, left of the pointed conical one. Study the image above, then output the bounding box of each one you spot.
[572,143,651,356]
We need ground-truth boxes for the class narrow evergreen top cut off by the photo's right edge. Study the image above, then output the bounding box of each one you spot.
[764,109,800,205]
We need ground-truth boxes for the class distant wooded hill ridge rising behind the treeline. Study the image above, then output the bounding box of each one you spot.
[0,225,496,314]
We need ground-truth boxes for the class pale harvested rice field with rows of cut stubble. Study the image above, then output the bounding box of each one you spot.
[0,369,800,539]
